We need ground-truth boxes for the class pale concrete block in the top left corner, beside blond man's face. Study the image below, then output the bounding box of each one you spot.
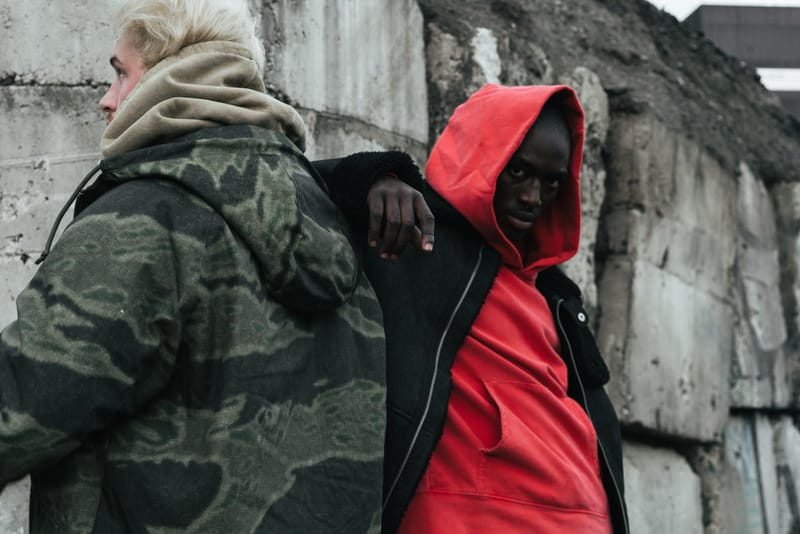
[0,0,114,85]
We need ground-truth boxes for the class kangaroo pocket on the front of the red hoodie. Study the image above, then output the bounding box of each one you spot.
[476,382,606,513]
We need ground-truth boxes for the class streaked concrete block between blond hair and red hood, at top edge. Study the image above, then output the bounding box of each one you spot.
[262,0,428,143]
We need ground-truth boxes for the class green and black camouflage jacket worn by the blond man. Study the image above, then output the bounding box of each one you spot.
[0,126,385,534]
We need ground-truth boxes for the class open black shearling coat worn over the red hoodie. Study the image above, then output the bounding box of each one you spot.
[314,152,630,534]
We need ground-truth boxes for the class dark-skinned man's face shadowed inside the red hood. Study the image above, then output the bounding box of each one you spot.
[493,113,570,255]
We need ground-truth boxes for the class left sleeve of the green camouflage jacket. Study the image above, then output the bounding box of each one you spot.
[0,195,180,487]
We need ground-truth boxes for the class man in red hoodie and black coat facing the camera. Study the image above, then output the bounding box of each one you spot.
[324,85,629,534]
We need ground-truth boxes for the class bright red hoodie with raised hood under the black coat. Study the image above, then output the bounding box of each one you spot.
[399,85,611,534]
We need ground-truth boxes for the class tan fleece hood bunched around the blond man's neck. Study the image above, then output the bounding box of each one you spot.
[100,41,305,158]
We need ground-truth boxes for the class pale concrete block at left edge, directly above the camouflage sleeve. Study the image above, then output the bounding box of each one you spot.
[0,86,105,328]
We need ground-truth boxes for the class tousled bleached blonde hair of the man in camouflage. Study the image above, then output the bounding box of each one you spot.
[116,0,265,75]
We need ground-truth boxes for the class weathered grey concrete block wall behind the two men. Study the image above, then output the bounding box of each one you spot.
[0,0,800,534]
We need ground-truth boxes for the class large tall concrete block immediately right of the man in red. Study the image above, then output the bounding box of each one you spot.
[598,116,737,441]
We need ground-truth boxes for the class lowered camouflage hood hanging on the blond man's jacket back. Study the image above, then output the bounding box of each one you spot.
[101,125,359,310]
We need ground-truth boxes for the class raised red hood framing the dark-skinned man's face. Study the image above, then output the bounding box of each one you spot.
[425,84,584,274]
